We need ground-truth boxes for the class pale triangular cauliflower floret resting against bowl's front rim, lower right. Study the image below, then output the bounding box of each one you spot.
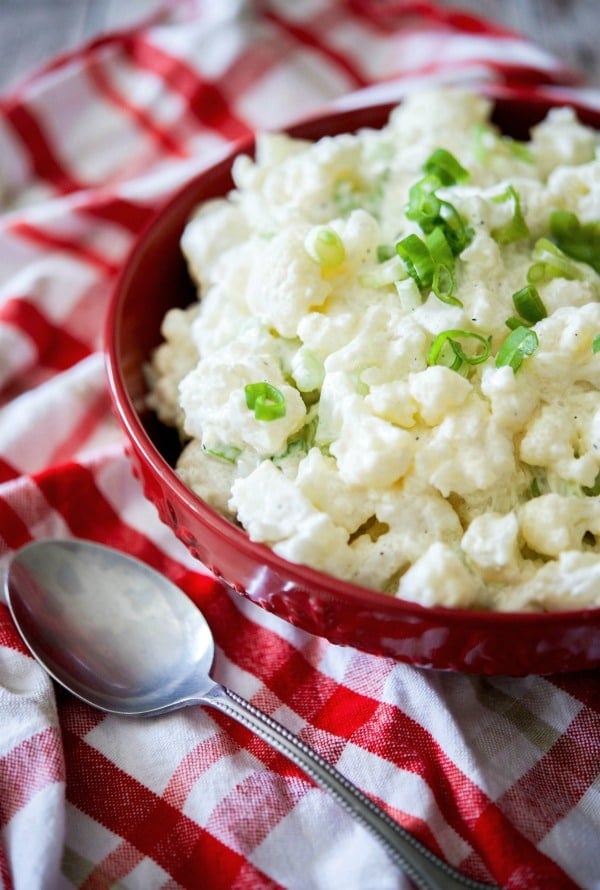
[396,541,480,608]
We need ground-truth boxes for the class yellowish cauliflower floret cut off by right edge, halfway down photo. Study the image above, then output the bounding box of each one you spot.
[519,392,600,488]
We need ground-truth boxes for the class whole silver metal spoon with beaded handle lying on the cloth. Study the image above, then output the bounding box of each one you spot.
[5,540,490,890]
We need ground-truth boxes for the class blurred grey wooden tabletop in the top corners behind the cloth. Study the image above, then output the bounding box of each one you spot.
[0,0,600,90]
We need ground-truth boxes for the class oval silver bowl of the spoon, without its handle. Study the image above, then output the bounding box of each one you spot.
[7,540,214,715]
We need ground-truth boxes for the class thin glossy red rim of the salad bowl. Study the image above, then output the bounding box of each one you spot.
[104,84,600,630]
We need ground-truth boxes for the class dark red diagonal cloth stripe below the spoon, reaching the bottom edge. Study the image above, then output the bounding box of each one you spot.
[63,728,278,890]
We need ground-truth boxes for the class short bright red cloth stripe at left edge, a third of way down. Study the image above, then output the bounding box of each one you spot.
[0,297,91,371]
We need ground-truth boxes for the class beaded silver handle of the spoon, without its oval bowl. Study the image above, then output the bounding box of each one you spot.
[202,683,492,890]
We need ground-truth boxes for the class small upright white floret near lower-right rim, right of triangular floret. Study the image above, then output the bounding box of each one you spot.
[460,512,523,584]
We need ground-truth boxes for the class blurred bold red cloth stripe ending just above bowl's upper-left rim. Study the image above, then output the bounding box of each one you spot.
[125,37,252,141]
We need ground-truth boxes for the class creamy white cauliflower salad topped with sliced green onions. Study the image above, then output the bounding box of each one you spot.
[148,89,600,610]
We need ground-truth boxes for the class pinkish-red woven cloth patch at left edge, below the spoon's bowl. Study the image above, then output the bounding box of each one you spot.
[0,726,65,827]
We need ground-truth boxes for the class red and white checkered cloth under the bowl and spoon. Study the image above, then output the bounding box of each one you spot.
[0,0,600,890]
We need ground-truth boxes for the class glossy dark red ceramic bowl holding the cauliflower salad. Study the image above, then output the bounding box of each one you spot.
[106,90,600,676]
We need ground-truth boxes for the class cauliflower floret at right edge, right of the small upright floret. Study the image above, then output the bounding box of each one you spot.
[518,492,600,556]
